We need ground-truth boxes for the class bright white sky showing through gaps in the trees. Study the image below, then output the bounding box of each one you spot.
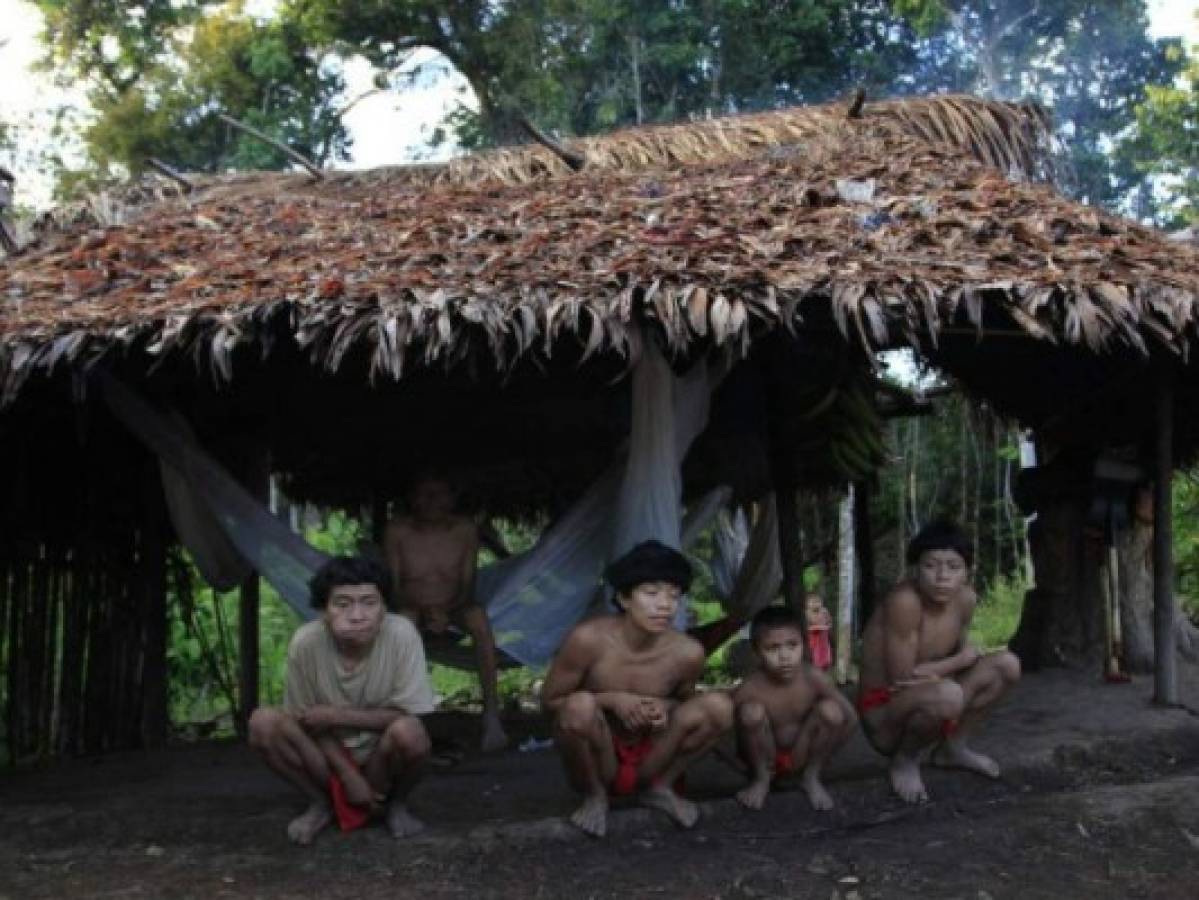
[0,0,1199,209]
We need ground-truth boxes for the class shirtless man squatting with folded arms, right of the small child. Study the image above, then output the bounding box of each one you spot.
[857,523,1020,803]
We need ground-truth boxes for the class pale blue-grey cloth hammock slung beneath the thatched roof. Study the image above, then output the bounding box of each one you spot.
[101,340,727,666]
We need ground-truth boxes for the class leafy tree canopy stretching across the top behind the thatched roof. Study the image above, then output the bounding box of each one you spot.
[25,0,1188,216]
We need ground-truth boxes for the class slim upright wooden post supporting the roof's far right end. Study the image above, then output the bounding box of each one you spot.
[1153,368,1179,706]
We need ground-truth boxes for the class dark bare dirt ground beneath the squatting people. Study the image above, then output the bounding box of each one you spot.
[7,672,1199,900]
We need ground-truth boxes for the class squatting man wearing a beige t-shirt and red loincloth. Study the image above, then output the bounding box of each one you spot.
[249,557,433,844]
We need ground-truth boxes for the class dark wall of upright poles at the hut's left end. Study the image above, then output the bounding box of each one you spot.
[0,405,168,765]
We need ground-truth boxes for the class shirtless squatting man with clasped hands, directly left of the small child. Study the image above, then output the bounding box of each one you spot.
[542,540,733,838]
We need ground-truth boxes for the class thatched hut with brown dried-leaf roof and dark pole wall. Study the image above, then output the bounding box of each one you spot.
[0,97,1199,754]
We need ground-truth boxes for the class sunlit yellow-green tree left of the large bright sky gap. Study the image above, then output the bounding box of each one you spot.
[38,0,348,186]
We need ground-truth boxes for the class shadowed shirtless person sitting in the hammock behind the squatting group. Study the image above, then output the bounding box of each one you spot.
[384,475,508,753]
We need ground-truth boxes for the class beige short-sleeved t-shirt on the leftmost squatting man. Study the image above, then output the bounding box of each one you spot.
[283,612,433,763]
